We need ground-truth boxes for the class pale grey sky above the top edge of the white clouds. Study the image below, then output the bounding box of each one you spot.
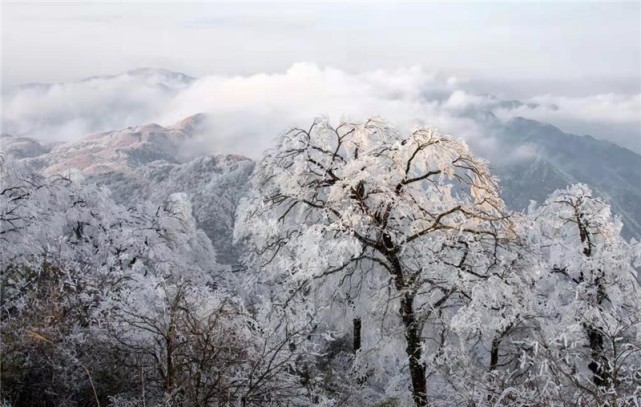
[2,1,641,96]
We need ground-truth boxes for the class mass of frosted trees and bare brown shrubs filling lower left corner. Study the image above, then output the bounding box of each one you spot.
[0,158,303,406]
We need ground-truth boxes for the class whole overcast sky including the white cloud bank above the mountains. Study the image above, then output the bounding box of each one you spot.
[0,1,641,153]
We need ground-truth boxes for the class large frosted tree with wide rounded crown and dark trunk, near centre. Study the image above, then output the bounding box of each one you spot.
[236,119,512,406]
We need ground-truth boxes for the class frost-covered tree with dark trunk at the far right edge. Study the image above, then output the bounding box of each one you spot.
[531,184,641,406]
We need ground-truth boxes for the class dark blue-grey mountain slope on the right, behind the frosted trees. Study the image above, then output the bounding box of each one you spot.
[496,117,641,237]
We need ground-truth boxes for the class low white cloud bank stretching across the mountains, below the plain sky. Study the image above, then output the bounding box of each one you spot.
[2,63,641,158]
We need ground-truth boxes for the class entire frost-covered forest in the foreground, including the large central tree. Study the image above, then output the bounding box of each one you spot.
[0,118,641,407]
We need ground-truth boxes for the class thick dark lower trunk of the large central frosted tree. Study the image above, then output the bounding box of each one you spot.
[387,255,427,407]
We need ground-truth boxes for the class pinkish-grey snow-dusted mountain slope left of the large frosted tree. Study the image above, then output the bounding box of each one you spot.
[7,115,254,264]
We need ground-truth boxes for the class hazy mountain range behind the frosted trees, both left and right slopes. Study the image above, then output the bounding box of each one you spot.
[0,69,641,264]
